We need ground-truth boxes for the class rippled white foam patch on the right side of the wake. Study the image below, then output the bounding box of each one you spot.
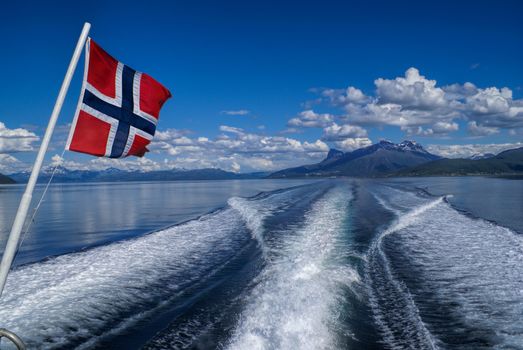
[392,197,523,348]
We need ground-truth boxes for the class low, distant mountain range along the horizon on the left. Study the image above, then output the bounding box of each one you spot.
[11,166,268,183]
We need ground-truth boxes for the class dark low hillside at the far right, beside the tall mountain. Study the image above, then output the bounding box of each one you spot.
[393,147,523,176]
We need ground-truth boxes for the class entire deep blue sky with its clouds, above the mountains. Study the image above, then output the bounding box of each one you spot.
[0,1,523,173]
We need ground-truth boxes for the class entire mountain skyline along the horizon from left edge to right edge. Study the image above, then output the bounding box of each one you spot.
[7,140,523,184]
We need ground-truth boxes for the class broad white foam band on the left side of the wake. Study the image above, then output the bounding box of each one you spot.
[0,209,248,349]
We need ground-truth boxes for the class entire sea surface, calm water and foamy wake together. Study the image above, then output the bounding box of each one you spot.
[0,178,523,350]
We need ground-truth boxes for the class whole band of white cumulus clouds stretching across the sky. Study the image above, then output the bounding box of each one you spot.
[6,68,523,172]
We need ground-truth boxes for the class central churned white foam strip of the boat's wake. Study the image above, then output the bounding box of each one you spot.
[228,187,359,350]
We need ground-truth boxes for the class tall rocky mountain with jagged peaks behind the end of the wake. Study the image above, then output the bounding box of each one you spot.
[269,141,440,178]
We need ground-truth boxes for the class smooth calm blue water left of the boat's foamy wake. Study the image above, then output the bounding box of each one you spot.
[0,180,311,265]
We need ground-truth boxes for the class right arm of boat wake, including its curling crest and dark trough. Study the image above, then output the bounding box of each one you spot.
[365,188,523,349]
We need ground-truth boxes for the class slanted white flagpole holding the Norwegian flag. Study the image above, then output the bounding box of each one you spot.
[0,22,91,296]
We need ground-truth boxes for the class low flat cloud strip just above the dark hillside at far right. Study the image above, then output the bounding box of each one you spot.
[427,142,523,158]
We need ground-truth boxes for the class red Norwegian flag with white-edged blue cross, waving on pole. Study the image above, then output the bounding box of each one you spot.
[66,38,171,158]
